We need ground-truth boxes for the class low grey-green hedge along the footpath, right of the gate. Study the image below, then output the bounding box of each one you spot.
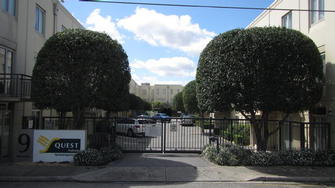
[202,144,335,166]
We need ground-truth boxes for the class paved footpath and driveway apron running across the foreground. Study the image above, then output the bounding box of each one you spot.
[0,154,335,183]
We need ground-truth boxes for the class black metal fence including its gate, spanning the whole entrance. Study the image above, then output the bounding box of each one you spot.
[22,117,331,152]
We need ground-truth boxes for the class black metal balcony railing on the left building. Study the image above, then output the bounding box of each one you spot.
[0,73,31,100]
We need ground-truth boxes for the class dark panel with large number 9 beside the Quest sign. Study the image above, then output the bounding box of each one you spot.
[15,129,34,161]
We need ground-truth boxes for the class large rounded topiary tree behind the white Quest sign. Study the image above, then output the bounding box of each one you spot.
[32,29,130,128]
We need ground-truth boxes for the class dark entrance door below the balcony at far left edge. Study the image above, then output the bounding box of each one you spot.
[0,103,10,160]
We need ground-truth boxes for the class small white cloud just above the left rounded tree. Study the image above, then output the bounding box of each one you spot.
[86,9,124,43]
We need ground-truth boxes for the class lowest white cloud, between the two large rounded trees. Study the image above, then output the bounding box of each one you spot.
[130,57,196,77]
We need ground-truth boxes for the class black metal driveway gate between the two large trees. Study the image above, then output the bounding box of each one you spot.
[116,118,213,153]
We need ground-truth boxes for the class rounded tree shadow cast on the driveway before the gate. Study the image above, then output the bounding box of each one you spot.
[77,153,202,186]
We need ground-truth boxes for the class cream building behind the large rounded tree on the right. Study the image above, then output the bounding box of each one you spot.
[247,0,335,148]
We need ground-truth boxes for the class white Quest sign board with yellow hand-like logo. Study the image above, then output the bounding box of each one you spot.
[33,130,86,162]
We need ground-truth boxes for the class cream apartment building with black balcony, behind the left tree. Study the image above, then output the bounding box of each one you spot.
[0,0,83,161]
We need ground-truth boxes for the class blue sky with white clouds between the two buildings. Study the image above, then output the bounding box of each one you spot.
[63,0,273,85]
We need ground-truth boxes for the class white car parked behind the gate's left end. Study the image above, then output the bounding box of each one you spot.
[116,119,156,137]
